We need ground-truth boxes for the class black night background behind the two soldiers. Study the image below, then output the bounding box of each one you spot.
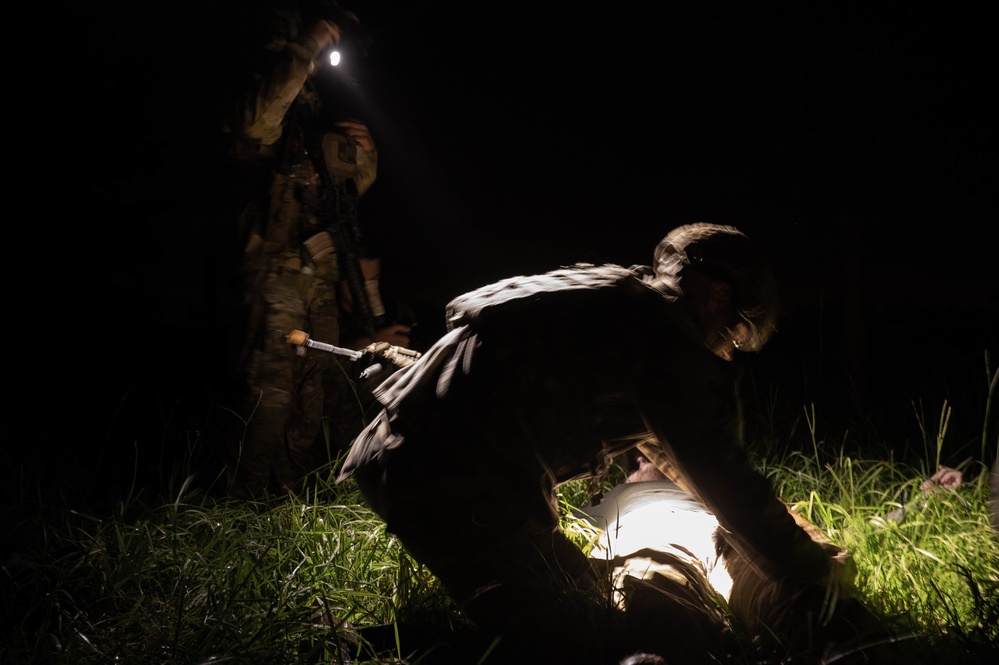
[13,0,999,498]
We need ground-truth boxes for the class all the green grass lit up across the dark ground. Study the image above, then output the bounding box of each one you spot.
[0,370,999,665]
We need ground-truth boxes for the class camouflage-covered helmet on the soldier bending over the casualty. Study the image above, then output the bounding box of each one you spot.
[653,222,778,351]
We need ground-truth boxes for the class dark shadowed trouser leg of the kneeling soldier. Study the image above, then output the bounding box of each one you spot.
[354,440,623,664]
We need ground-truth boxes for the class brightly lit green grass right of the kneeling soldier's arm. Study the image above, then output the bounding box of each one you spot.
[773,456,999,643]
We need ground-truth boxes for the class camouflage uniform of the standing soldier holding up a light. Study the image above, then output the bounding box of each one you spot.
[224,2,377,497]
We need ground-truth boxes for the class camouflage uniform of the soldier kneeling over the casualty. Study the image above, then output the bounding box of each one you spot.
[339,256,828,662]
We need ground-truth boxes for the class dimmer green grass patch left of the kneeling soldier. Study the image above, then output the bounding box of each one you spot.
[0,462,462,663]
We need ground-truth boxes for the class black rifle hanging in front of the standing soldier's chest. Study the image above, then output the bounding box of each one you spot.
[304,133,385,339]
